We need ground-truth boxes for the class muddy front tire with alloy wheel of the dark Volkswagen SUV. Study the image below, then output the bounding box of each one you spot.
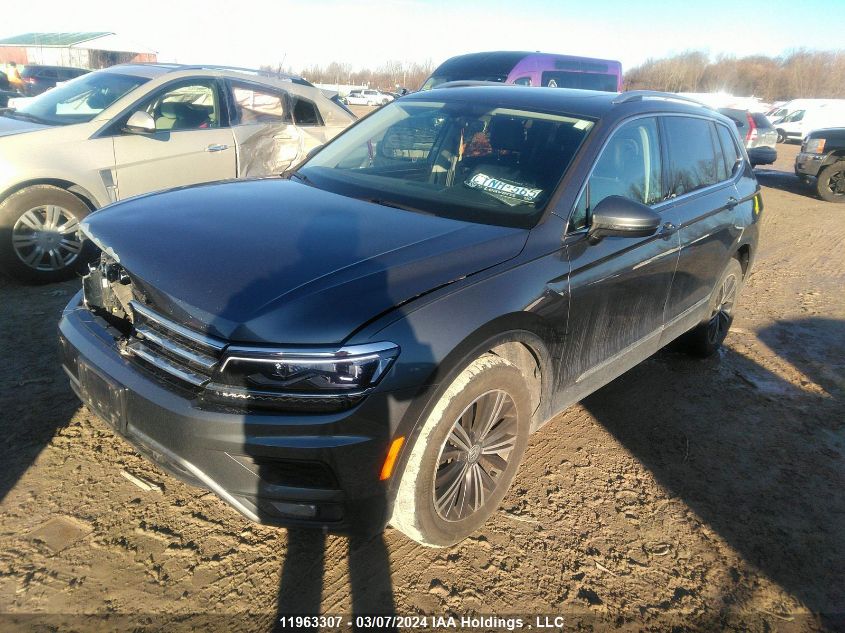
[390,354,531,547]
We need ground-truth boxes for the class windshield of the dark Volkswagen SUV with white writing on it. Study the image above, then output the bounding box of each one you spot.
[294,101,593,228]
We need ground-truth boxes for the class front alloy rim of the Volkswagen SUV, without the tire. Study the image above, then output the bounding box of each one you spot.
[434,390,517,521]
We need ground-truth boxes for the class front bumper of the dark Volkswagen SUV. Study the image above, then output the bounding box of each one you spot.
[59,293,402,533]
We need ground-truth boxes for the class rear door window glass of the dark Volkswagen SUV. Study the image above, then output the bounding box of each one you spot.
[663,116,722,196]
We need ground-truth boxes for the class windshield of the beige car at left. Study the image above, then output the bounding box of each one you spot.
[11,72,149,125]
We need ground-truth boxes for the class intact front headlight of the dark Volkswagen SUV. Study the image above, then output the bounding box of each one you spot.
[204,343,399,412]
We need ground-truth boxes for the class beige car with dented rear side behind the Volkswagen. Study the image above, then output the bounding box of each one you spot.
[0,64,355,282]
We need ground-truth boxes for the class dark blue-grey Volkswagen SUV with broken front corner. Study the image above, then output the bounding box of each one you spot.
[60,85,762,546]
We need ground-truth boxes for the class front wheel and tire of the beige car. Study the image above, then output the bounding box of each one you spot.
[0,185,96,283]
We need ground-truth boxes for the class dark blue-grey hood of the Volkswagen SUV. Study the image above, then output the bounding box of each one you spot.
[83,179,528,344]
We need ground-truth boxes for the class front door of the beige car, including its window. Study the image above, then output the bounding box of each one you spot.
[114,78,236,199]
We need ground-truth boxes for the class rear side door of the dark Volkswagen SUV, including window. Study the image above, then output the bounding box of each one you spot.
[657,115,747,339]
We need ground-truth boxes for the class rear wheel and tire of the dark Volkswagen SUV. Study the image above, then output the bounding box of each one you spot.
[680,259,743,358]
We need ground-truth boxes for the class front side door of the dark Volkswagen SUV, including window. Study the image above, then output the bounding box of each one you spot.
[561,117,679,388]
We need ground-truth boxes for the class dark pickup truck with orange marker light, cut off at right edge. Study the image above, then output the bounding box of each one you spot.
[795,127,845,202]
